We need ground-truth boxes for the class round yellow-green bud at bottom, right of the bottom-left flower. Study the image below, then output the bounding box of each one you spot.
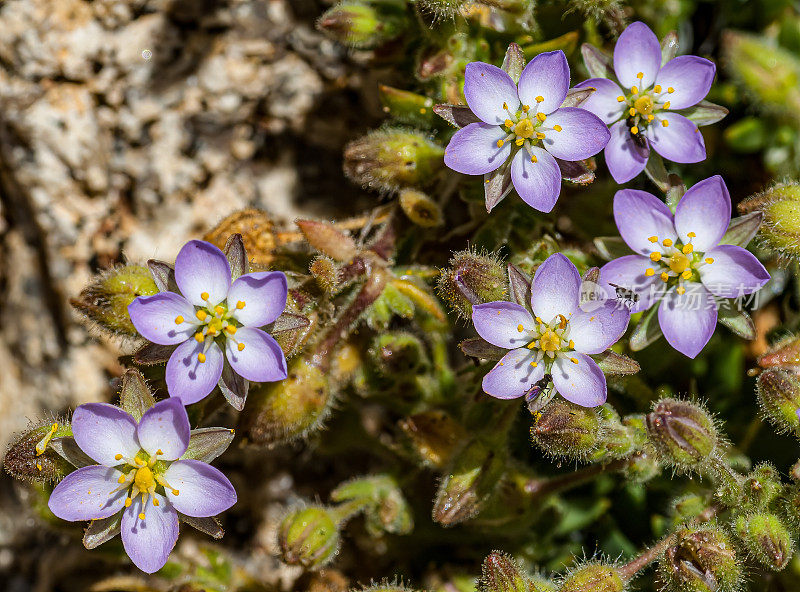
[278,506,339,569]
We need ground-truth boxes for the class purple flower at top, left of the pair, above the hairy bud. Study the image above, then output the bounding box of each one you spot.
[444,51,609,212]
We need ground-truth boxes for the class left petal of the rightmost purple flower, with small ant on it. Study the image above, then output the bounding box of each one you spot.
[599,255,664,314]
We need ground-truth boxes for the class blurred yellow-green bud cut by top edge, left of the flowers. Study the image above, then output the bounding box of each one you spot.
[317,0,407,49]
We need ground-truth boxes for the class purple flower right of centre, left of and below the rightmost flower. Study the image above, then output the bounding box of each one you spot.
[472,253,630,407]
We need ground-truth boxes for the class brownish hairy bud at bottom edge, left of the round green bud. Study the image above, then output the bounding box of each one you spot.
[658,527,742,592]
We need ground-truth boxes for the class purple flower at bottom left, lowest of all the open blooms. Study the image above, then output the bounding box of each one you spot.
[48,399,236,573]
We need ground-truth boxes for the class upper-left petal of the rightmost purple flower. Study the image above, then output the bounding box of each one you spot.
[614,189,678,256]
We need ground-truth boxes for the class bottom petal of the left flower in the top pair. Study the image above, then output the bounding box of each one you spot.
[511,147,561,212]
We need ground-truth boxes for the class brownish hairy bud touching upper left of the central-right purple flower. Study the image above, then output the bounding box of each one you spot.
[436,250,508,319]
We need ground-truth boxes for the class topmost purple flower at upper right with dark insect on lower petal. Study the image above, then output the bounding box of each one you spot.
[576,22,716,183]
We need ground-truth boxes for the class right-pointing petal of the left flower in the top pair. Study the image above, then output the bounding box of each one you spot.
[543,107,611,160]
